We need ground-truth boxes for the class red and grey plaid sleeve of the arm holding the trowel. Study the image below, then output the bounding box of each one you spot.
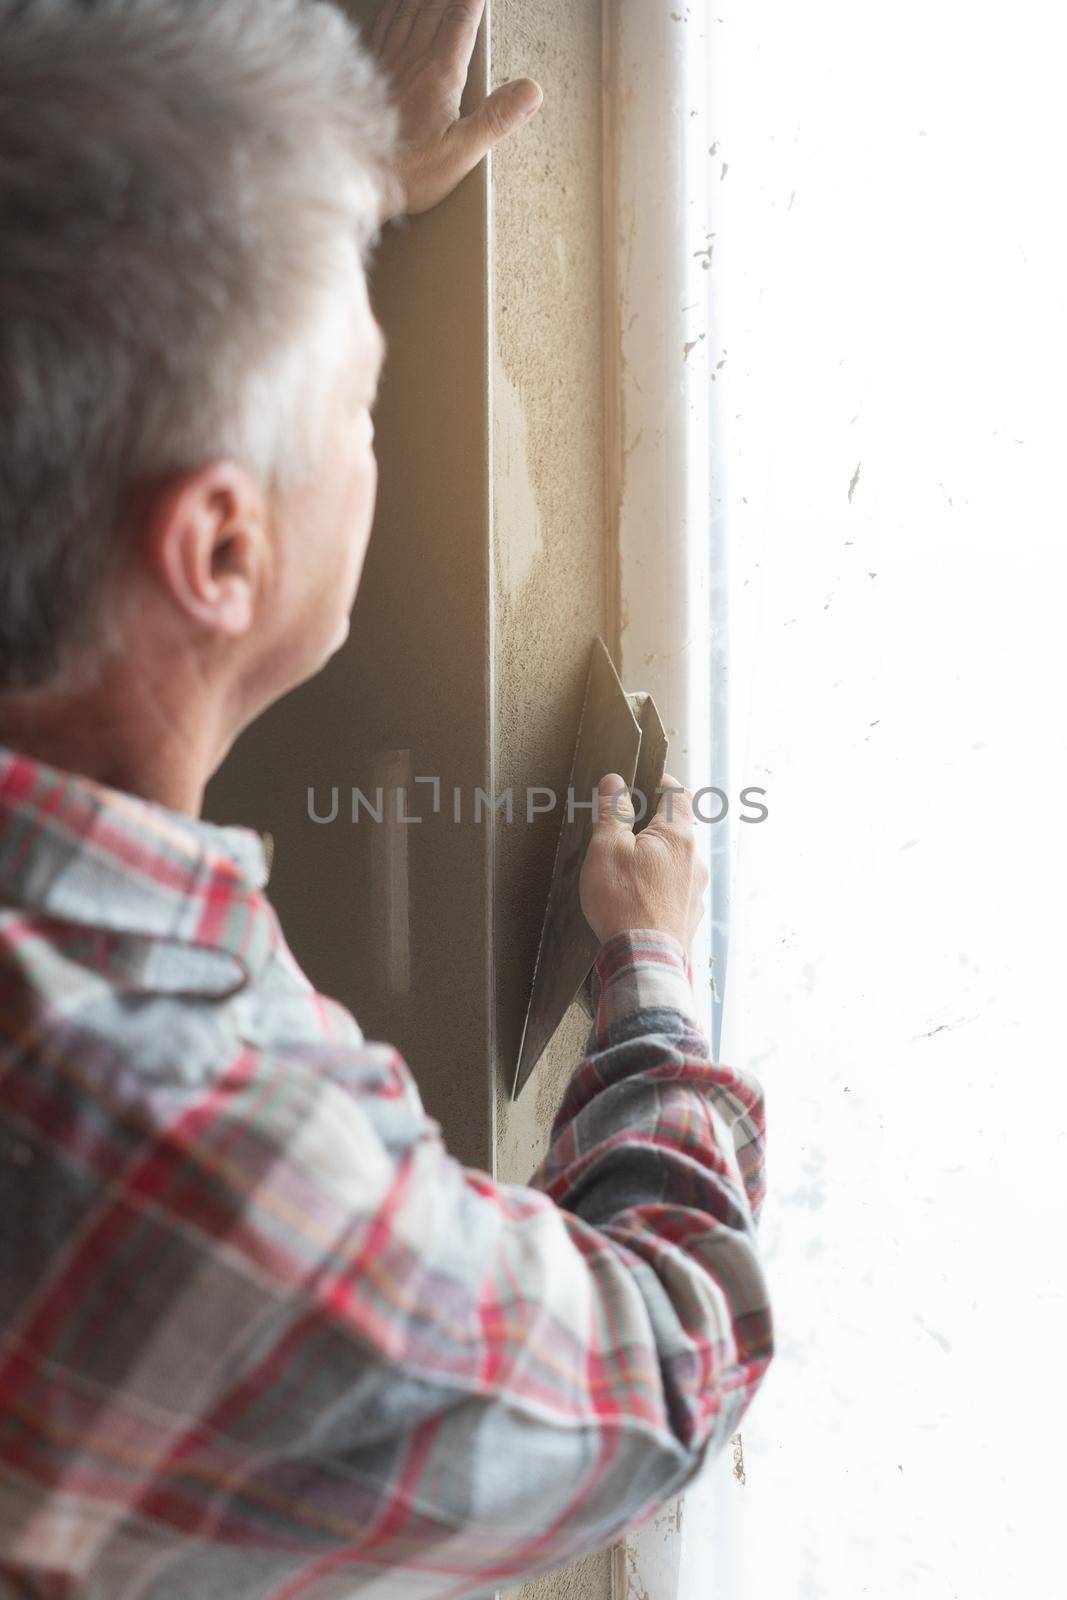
[163,930,773,1595]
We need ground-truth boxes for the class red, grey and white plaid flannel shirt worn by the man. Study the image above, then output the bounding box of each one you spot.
[0,752,773,1600]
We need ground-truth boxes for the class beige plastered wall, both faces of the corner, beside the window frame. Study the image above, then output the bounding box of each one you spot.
[208,0,611,1600]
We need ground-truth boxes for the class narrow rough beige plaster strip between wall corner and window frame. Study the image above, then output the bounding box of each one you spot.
[490,0,611,1600]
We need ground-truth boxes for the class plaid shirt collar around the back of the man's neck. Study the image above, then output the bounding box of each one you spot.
[0,747,277,997]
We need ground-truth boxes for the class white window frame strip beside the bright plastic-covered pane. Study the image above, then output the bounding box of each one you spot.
[603,0,736,1600]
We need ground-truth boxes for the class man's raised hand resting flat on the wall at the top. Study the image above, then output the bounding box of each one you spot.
[370,0,542,222]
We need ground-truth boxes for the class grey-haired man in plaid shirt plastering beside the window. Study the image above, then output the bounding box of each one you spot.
[0,0,773,1600]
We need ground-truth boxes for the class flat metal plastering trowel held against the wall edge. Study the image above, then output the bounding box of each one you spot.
[512,638,667,1099]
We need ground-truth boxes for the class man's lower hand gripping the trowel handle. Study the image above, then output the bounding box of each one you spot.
[579,773,707,950]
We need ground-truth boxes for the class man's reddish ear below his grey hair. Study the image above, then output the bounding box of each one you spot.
[144,461,270,638]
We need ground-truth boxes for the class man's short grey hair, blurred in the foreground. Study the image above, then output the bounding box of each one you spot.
[0,0,397,688]
